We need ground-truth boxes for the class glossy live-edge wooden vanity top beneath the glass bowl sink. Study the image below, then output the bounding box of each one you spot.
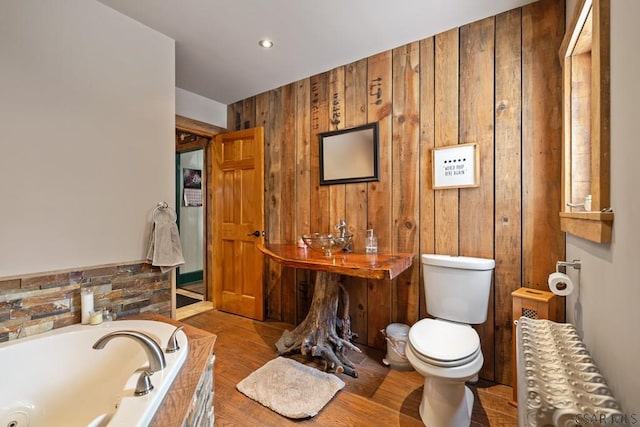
[258,243,414,279]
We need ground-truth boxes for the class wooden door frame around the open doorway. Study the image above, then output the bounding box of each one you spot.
[175,115,226,308]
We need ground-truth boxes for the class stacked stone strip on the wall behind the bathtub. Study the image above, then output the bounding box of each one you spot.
[0,262,171,342]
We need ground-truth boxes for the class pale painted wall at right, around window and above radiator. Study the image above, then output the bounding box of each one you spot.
[567,0,640,419]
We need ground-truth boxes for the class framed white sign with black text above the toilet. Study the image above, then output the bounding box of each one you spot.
[432,143,480,189]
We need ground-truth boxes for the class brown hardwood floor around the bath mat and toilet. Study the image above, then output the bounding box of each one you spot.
[182,310,517,427]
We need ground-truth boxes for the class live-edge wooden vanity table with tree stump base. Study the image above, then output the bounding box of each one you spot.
[258,244,413,377]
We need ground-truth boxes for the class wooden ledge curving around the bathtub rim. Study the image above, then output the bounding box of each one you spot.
[129,313,216,426]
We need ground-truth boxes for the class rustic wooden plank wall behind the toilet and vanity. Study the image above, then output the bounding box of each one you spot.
[228,0,564,384]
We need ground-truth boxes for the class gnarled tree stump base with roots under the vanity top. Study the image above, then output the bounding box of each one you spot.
[276,271,361,378]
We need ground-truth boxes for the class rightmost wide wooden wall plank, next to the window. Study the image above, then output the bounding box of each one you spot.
[522,0,565,321]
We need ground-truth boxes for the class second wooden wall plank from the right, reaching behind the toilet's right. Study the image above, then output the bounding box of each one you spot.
[494,9,522,384]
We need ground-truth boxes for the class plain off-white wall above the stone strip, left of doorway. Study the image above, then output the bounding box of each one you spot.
[0,0,175,277]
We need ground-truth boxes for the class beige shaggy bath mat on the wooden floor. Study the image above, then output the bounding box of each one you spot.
[236,357,344,418]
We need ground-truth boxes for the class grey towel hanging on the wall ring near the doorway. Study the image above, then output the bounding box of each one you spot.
[147,217,184,273]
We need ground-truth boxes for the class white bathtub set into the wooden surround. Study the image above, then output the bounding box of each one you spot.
[0,320,188,427]
